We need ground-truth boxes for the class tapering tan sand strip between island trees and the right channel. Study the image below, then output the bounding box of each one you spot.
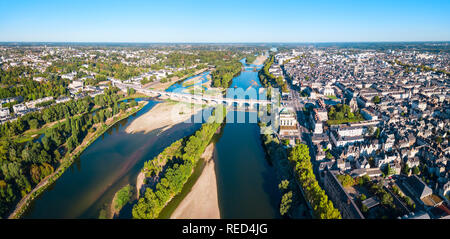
[170,144,220,219]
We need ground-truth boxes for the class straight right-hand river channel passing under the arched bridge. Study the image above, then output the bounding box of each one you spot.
[214,59,280,219]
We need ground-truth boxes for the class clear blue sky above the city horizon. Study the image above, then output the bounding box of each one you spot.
[0,0,450,42]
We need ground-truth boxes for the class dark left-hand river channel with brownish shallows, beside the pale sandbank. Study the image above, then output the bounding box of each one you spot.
[24,101,205,218]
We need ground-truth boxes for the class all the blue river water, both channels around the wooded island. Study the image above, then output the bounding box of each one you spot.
[24,57,280,218]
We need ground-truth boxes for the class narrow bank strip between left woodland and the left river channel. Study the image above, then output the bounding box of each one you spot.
[8,102,148,219]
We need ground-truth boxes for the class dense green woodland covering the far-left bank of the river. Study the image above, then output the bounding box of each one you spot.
[0,88,137,217]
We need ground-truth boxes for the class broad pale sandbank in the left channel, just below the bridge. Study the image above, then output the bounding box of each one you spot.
[125,102,201,134]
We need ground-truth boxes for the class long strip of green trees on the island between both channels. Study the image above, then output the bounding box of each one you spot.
[133,108,226,219]
